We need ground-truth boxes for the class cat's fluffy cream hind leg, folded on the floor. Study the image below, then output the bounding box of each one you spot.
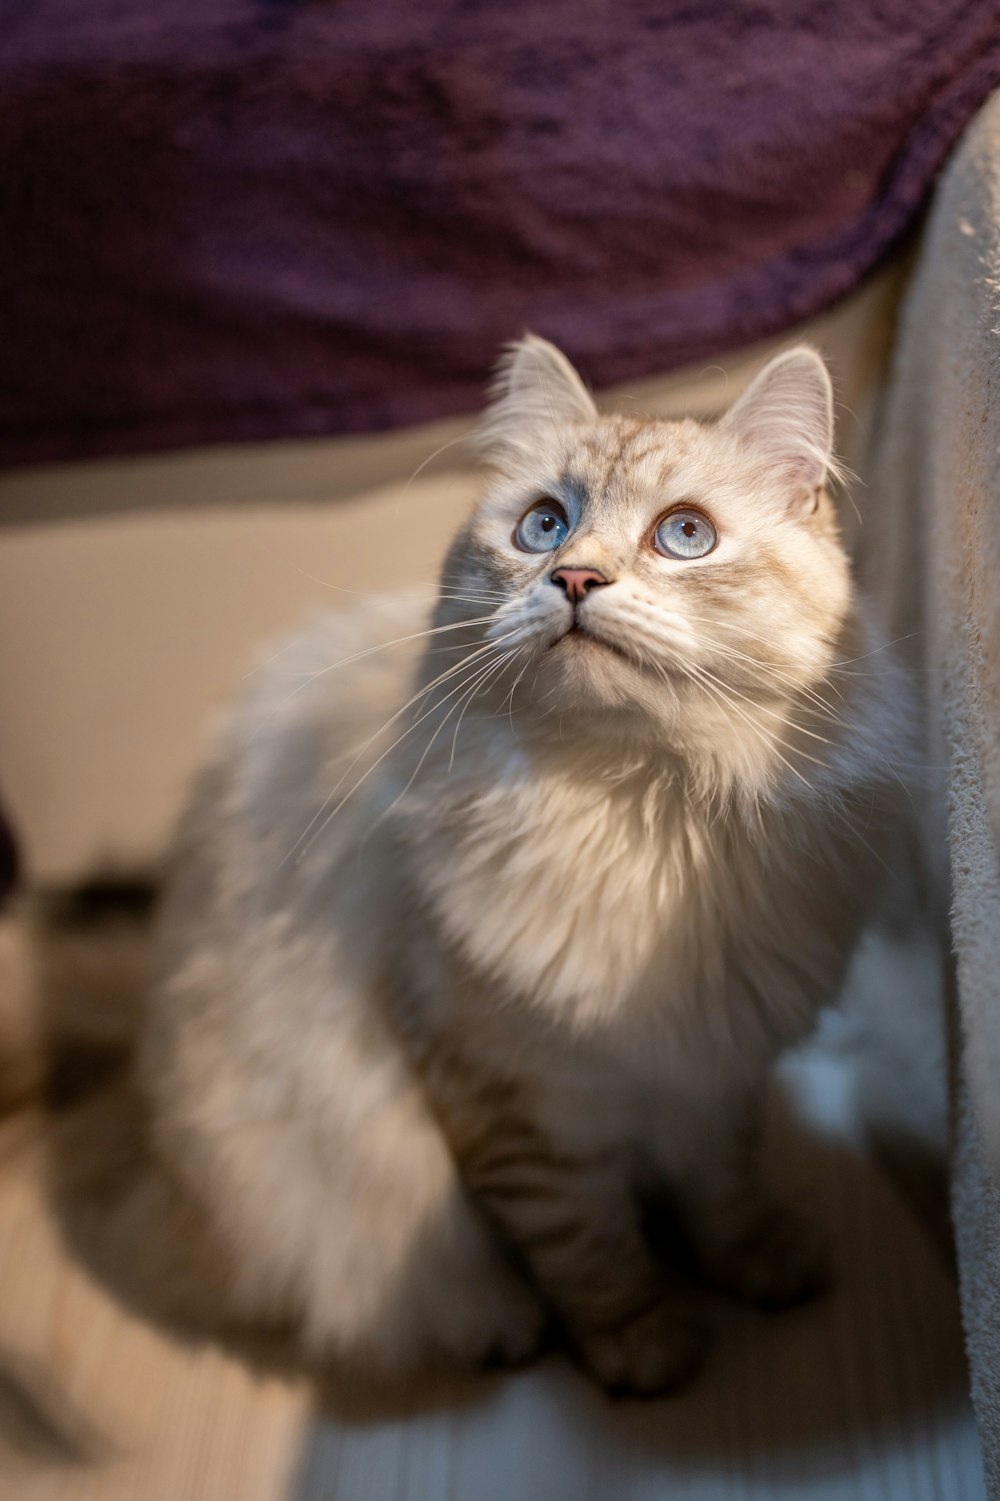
[149,977,550,1379]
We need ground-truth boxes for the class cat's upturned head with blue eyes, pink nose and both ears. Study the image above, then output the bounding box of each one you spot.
[438,336,851,778]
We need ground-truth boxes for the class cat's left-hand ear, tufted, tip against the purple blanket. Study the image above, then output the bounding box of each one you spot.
[473,333,598,464]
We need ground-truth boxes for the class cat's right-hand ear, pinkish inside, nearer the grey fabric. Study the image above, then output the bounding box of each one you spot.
[721,344,838,510]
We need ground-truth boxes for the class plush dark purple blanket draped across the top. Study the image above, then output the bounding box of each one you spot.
[0,0,1000,462]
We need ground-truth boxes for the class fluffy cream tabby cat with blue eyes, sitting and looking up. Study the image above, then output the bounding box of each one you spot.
[137,335,908,1394]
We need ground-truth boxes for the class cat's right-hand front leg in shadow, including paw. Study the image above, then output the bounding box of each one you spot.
[674,1085,830,1307]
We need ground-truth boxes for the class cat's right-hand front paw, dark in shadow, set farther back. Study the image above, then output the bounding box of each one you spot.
[704,1205,833,1309]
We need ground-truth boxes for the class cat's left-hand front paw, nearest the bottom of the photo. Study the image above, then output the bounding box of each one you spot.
[577,1298,707,1397]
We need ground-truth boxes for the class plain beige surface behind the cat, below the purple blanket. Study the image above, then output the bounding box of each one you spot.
[0,270,899,877]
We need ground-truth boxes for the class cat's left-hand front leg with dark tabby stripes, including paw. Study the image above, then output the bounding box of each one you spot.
[441,1078,706,1394]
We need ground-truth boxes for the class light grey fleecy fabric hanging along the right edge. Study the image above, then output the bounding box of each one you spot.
[866,93,1000,1496]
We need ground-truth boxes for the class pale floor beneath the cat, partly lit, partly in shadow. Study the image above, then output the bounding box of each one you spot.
[0,960,983,1501]
